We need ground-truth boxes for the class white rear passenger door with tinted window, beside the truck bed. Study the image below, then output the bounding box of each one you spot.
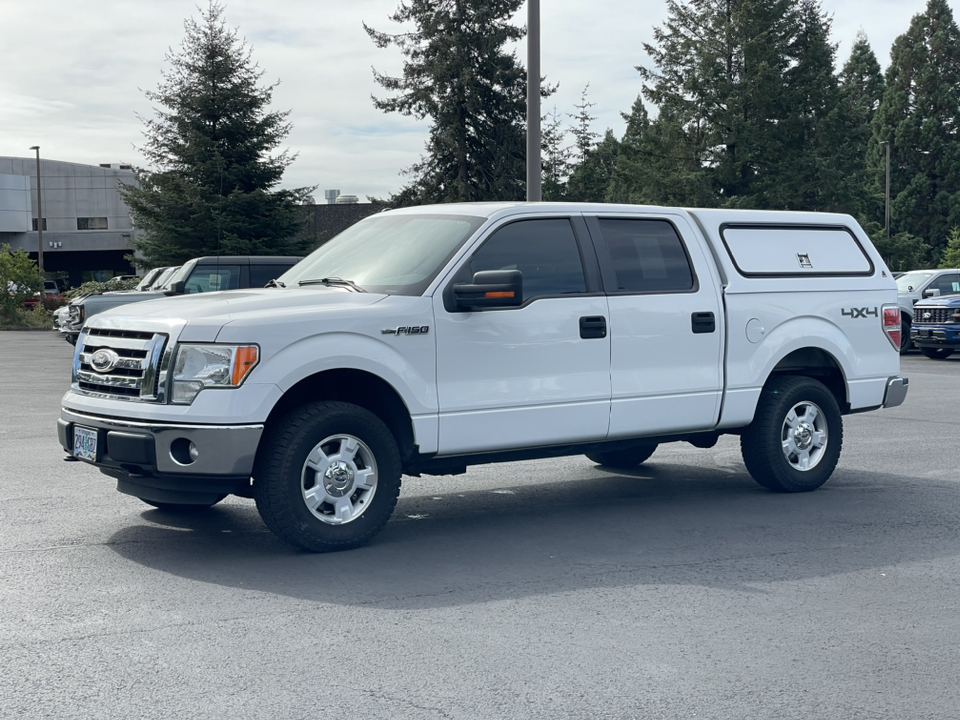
[587,215,724,438]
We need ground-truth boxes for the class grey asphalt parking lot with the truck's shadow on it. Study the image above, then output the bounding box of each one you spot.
[0,332,960,720]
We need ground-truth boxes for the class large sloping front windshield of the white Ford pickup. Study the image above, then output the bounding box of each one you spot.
[279,214,485,295]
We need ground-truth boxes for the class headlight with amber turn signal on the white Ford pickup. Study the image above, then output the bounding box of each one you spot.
[170,345,260,405]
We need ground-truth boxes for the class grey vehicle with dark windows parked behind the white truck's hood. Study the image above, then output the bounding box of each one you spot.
[61,255,302,345]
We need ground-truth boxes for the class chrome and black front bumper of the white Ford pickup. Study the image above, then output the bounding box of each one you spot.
[57,408,263,502]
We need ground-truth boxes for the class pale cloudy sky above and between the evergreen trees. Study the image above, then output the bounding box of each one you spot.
[0,0,960,202]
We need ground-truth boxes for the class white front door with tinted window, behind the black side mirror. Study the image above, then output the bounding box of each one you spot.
[434,217,610,455]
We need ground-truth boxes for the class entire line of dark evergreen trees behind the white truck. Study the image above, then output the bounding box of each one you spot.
[124,0,960,270]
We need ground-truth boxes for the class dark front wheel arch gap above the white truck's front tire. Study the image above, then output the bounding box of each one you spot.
[266,368,416,462]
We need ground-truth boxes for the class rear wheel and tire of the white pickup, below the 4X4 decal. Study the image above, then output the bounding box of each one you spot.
[740,376,843,492]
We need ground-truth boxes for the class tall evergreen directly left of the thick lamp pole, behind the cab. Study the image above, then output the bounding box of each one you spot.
[364,0,532,205]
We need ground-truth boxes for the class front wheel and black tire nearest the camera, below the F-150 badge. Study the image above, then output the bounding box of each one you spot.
[253,402,401,552]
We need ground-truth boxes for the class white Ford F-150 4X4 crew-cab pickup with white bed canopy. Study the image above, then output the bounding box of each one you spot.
[58,203,907,551]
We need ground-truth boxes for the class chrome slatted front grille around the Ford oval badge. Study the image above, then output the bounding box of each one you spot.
[73,328,168,402]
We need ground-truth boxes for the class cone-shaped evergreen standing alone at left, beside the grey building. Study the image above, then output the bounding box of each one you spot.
[121,0,312,267]
